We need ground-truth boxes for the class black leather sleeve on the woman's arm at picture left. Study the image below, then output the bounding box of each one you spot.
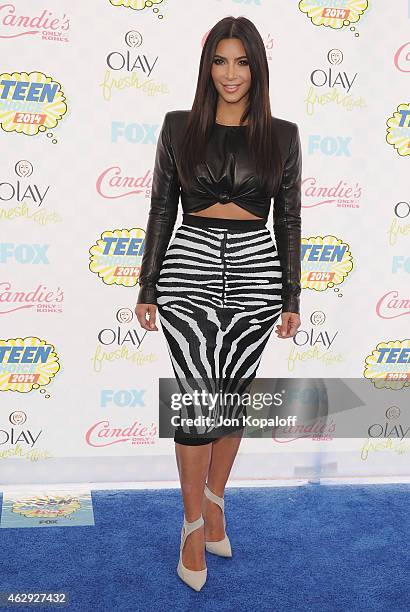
[137,112,181,304]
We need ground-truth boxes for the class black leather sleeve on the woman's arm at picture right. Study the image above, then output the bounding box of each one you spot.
[273,123,302,313]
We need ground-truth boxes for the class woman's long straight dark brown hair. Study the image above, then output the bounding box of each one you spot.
[179,16,283,195]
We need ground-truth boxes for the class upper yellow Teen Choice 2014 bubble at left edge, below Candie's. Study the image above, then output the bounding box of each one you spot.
[0,71,67,136]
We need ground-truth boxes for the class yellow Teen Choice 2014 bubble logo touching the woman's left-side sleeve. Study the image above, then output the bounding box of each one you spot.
[90,227,145,287]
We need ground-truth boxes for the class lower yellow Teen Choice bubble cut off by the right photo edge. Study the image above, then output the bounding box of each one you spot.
[364,339,410,389]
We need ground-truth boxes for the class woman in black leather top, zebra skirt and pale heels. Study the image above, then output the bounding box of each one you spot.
[136,17,302,590]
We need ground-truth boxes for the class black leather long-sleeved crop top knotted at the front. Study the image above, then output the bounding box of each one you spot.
[137,110,302,313]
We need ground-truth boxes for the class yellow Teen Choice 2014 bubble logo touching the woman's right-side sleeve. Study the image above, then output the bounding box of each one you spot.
[301,236,353,291]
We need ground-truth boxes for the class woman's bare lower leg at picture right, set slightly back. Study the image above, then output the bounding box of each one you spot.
[202,429,244,542]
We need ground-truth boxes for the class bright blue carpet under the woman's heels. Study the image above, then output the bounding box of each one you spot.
[0,484,410,612]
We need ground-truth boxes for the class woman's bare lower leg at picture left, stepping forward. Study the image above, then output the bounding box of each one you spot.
[175,442,212,570]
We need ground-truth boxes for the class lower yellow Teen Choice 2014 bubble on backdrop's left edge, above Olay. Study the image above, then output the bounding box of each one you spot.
[0,336,60,393]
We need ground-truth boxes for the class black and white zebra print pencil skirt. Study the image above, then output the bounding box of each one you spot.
[156,213,282,445]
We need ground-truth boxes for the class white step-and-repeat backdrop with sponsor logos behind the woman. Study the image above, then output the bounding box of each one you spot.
[0,0,410,483]
